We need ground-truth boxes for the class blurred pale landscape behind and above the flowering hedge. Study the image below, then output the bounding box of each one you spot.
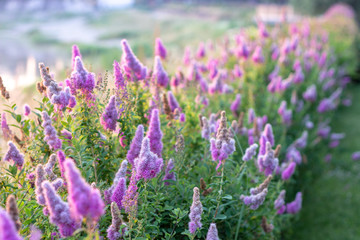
[0,0,360,107]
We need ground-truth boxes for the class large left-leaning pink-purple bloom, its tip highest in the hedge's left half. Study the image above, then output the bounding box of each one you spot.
[121,39,147,81]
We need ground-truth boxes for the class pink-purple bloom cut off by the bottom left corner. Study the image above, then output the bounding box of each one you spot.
[0,207,23,240]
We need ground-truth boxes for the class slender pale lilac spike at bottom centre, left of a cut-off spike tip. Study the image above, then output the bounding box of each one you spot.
[189,187,203,234]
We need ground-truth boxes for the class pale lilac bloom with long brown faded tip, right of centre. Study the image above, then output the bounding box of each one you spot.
[210,111,235,168]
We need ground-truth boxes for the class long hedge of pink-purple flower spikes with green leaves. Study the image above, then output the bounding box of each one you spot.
[0,7,359,240]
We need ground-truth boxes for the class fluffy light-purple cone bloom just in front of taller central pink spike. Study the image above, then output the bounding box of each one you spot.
[135,137,163,180]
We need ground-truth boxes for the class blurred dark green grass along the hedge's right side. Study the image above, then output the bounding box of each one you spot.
[289,84,360,240]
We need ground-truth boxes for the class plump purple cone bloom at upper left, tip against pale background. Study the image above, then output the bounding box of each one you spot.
[70,56,95,94]
